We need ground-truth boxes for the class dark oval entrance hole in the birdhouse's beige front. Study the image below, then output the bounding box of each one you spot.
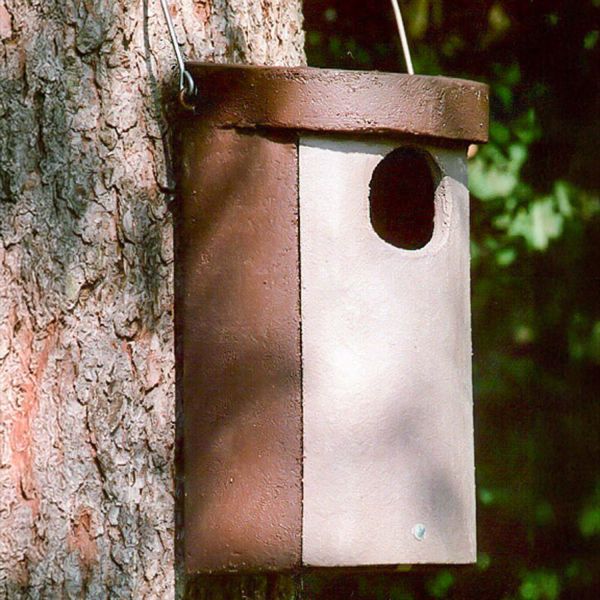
[369,148,437,250]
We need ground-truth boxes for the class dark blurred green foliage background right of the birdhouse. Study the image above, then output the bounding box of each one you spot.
[304,0,600,600]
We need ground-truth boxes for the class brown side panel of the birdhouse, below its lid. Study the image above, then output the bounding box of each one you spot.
[178,124,302,572]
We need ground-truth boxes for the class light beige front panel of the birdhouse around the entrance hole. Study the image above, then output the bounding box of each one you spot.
[299,137,475,566]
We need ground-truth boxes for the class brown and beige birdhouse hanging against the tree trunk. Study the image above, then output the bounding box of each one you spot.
[176,63,488,572]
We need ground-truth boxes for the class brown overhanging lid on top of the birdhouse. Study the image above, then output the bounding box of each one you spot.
[188,62,488,142]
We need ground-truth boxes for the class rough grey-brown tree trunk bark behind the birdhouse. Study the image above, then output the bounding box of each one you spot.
[0,0,304,599]
